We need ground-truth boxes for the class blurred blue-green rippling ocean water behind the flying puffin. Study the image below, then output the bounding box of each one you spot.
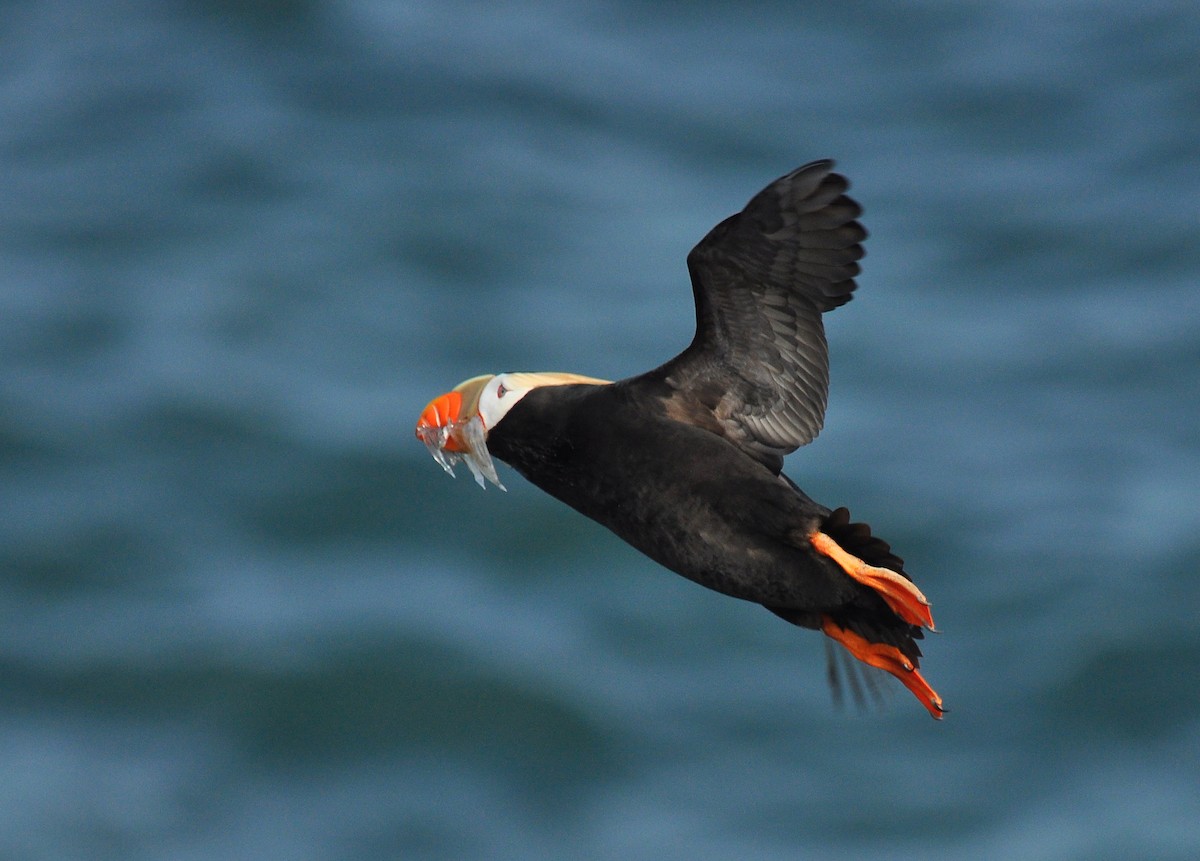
[0,0,1200,861]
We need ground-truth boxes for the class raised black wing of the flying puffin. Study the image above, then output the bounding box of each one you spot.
[629,161,866,471]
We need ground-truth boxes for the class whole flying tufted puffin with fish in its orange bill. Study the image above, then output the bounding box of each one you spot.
[416,161,944,718]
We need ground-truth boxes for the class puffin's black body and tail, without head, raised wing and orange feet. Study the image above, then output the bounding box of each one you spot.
[487,379,920,657]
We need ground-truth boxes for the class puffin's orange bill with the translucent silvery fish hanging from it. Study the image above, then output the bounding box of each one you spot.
[416,374,508,490]
